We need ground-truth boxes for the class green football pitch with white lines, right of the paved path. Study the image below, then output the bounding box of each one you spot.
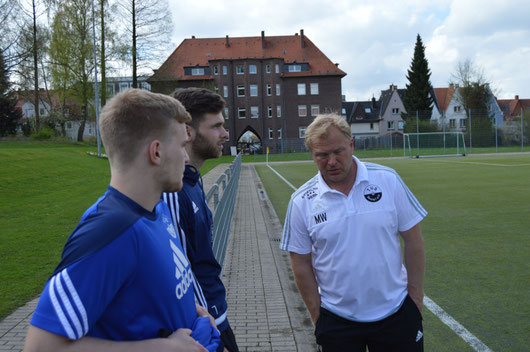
[256,154,530,352]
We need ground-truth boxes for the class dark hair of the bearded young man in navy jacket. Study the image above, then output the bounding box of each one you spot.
[170,88,225,128]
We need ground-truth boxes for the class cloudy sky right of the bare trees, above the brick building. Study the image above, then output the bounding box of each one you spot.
[168,0,530,101]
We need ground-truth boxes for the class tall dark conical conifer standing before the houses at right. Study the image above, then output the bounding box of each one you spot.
[403,34,433,120]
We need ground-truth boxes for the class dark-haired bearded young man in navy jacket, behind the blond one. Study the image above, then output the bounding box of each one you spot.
[160,88,238,352]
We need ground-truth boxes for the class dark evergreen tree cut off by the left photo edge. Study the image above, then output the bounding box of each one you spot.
[0,50,21,137]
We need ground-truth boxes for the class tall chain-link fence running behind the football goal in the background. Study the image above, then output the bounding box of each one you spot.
[249,109,530,161]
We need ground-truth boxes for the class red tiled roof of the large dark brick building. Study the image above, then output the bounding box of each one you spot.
[149,35,346,81]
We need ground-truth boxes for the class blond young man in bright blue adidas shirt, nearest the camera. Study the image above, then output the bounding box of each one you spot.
[24,89,219,352]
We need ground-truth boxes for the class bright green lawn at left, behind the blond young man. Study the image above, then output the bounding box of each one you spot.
[0,141,221,319]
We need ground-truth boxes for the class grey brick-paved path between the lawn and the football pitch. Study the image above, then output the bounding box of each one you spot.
[0,164,316,352]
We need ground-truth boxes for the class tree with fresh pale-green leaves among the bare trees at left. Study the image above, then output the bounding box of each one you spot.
[50,0,94,141]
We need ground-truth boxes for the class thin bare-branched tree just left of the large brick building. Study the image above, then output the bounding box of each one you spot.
[119,0,172,88]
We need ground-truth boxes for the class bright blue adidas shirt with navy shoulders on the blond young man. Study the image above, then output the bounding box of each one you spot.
[31,186,197,341]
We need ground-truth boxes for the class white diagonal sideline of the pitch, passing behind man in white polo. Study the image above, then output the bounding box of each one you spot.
[267,164,493,352]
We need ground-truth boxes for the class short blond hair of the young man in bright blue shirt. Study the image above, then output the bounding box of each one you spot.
[99,89,191,165]
